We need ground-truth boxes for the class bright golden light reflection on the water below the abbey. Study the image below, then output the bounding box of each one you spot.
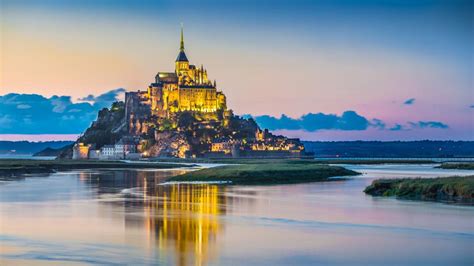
[144,185,224,265]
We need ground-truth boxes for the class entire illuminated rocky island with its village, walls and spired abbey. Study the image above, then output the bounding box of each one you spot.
[65,29,305,159]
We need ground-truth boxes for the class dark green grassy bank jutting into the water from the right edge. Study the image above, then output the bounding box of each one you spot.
[364,176,474,204]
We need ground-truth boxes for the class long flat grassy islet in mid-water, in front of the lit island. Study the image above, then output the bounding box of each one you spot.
[168,160,358,185]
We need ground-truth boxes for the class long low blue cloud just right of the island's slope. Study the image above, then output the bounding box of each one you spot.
[250,111,372,132]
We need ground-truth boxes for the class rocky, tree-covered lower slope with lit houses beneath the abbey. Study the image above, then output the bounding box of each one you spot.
[63,96,304,158]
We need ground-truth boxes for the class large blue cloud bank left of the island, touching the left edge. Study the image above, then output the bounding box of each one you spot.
[0,89,125,134]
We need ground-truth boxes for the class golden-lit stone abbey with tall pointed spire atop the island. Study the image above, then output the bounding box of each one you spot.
[125,29,227,132]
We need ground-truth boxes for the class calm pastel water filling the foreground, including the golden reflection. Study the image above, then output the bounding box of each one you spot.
[0,165,474,265]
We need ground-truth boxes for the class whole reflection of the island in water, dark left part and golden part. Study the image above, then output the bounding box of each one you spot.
[87,171,228,265]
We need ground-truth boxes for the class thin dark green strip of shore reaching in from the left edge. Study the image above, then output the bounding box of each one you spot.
[0,159,189,179]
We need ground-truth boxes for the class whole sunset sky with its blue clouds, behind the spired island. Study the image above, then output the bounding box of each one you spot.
[0,0,474,140]
